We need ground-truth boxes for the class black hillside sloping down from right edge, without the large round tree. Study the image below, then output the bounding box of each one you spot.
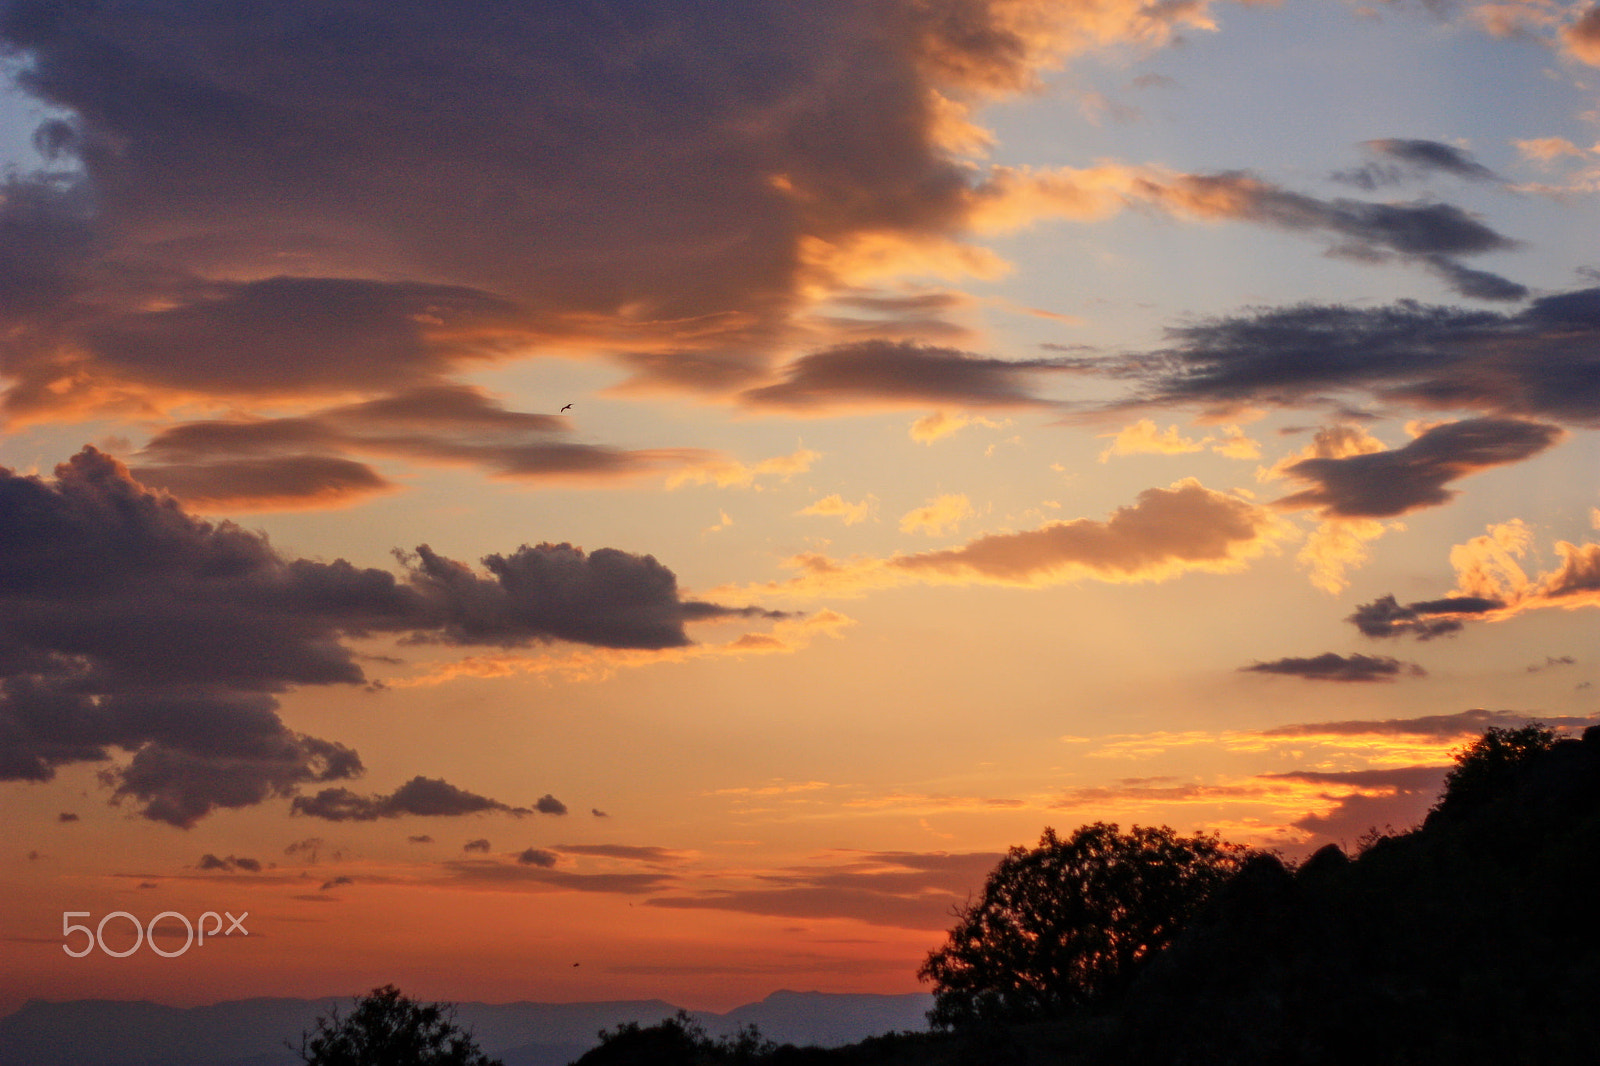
[578,723,1600,1066]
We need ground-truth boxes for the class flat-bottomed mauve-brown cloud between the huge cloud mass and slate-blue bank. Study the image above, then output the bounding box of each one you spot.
[742,341,1078,410]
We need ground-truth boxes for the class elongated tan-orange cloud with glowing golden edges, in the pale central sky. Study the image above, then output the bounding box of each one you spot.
[745,479,1288,595]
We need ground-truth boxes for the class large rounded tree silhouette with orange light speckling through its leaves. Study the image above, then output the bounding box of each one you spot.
[917,823,1250,1028]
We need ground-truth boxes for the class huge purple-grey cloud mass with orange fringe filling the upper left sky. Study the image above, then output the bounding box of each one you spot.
[0,0,1107,410]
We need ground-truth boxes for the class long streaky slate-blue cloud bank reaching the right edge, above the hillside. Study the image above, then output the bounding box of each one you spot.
[1102,288,1600,426]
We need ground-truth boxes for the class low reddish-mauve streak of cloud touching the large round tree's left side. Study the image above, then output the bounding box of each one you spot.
[646,852,1002,930]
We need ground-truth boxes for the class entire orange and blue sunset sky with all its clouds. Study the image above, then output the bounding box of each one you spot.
[0,0,1600,1012]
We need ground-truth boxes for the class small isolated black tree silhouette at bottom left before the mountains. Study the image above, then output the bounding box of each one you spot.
[294,984,502,1066]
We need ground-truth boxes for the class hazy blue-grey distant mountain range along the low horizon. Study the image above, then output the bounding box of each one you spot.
[0,991,933,1066]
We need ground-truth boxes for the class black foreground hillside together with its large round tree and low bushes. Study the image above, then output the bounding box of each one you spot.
[308,725,1600,1066]
